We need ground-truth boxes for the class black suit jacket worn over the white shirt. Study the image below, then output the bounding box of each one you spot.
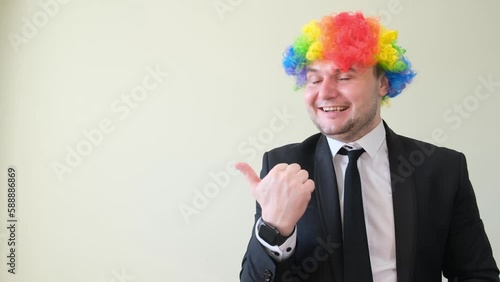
[240,123,499,282]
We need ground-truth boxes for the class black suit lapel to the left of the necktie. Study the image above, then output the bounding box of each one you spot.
[314,135,344,282]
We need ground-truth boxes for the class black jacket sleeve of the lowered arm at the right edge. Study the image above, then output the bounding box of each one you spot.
[443,154,500,282]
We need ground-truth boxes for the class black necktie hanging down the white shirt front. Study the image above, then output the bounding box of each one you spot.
[339,148,373,282]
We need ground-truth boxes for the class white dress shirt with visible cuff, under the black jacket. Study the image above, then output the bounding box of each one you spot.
[255,121,397,282]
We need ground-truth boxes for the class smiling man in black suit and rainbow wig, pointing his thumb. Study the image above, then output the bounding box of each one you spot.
[236,13,499,282]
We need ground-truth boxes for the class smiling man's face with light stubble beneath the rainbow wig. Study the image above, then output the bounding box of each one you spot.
[304,61,388,142]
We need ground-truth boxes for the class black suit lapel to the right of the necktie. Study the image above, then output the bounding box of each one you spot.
[384,122,417,282]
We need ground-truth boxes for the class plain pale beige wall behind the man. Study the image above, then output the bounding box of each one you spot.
[0,0,500,282]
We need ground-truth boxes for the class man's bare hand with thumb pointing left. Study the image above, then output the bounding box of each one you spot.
[235,163,314,236]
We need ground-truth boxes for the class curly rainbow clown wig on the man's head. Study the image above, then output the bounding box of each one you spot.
[283,12,415,102]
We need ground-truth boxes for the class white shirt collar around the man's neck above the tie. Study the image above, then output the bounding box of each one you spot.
[326,121,385,158]
